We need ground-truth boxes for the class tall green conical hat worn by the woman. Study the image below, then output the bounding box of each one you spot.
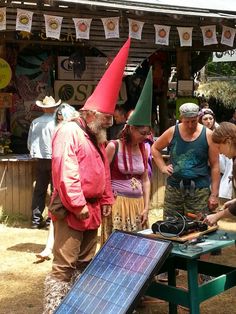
[127,67,153,126]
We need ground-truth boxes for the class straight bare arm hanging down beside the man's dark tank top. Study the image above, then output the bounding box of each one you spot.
[207,129,220,210]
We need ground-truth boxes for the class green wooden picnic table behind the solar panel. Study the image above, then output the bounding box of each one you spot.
[146,230,236,314]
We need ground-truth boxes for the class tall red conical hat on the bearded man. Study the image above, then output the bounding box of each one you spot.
[82,38,130,115]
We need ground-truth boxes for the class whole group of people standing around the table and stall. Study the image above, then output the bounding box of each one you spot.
[28,39,236,314]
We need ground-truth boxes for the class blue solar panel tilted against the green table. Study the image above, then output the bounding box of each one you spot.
[55,230,172,314]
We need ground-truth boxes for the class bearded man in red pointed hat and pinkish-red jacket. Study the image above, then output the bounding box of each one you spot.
[44,39,130,313]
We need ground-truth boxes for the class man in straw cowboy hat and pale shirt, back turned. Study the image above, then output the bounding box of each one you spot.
[27,96,61,229]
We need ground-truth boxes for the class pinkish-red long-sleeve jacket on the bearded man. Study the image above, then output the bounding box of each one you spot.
[52,120,114,231]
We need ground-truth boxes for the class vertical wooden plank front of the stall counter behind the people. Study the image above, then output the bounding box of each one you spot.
[0,156,169,220]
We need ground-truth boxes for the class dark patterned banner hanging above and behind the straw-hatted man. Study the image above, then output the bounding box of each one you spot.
[10,51,54,138]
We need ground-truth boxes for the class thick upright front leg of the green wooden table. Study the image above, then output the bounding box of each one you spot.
[187,259,200,314]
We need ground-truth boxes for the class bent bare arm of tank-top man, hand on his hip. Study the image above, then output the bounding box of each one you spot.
[151,127,175,175]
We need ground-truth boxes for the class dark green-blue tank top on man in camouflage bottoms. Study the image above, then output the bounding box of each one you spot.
[167,125,210,188]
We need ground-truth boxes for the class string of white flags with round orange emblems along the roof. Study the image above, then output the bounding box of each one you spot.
[0,7,236,47]
